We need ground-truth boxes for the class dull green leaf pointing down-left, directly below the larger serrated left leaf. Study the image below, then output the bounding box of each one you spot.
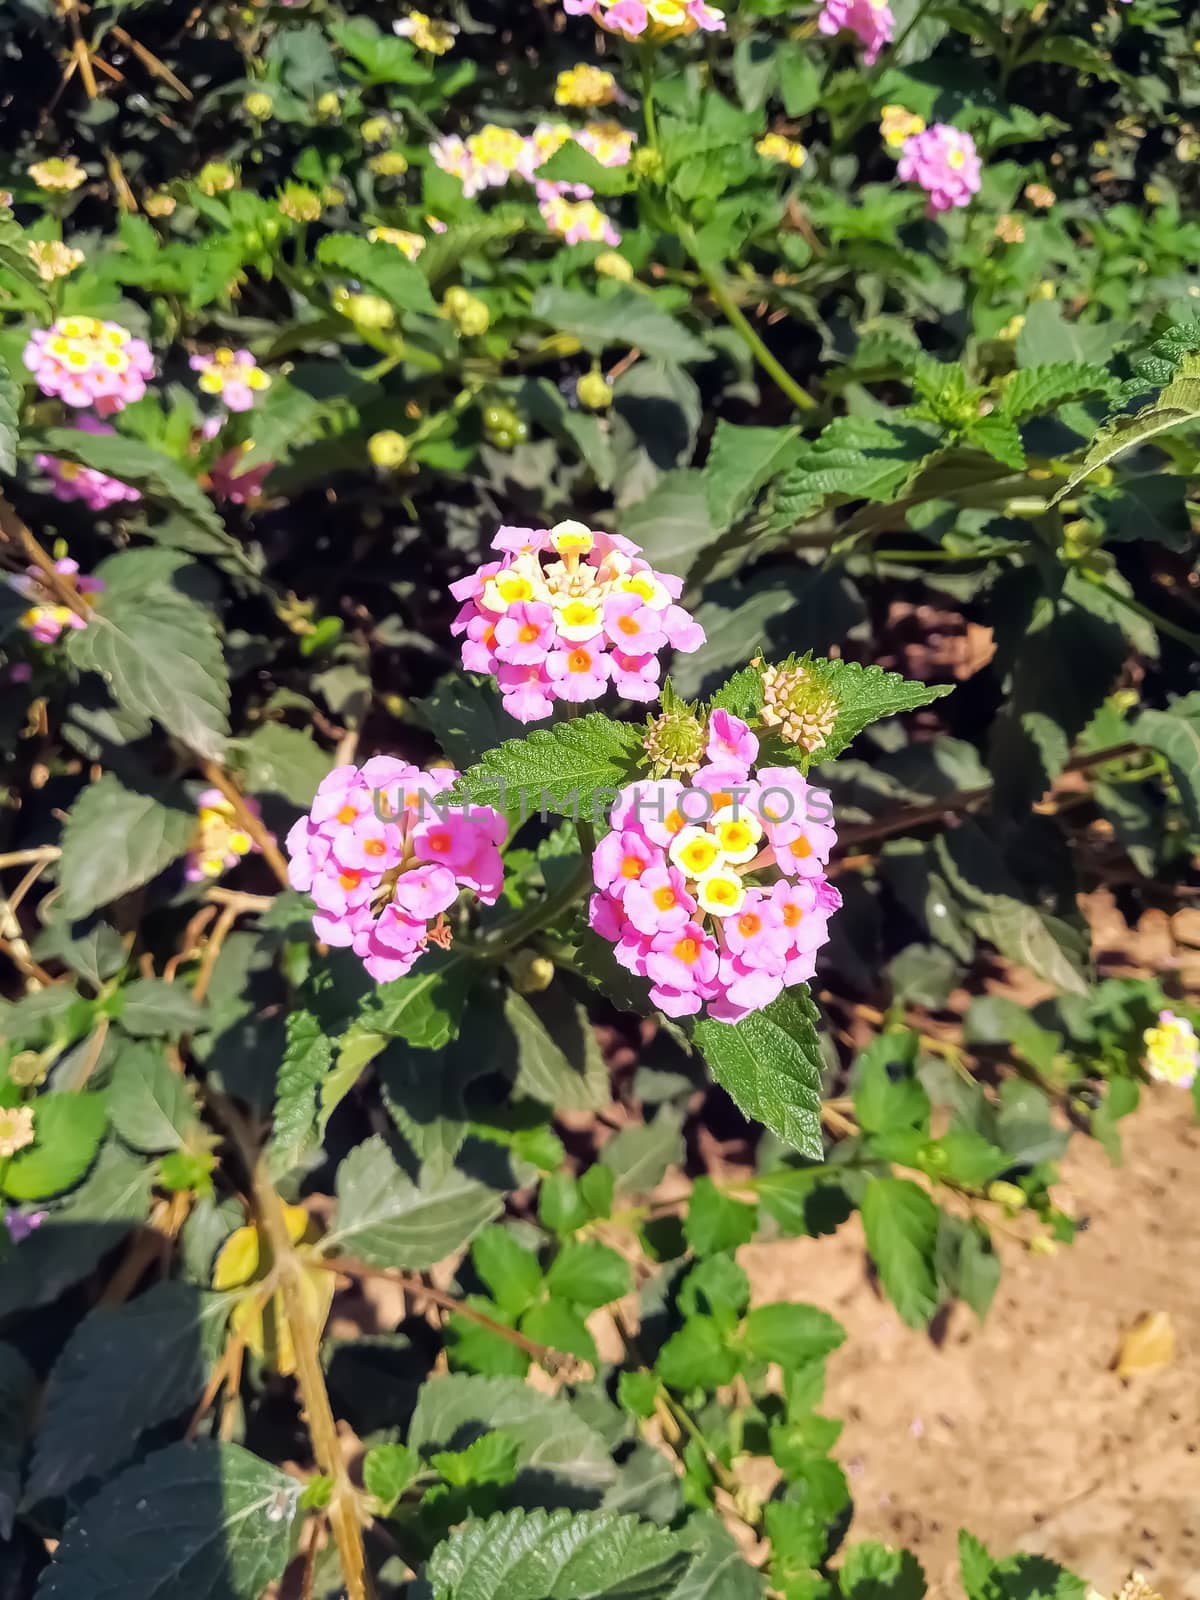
[59,773,197,920]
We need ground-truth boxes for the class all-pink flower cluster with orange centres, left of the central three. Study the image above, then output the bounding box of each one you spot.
[288,755,507,982]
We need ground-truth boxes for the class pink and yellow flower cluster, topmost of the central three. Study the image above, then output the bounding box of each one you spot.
[450,522,704,722]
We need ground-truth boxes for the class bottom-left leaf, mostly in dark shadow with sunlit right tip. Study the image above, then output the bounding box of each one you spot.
[37,1442,302,1600]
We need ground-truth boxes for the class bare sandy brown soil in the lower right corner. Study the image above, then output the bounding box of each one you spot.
[739,1088,1200,1600]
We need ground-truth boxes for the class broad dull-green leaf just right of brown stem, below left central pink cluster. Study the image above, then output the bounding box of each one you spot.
[325,1134,502,1272]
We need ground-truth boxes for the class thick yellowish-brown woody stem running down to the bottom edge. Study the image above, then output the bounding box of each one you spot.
[254,1160,374,1600]
